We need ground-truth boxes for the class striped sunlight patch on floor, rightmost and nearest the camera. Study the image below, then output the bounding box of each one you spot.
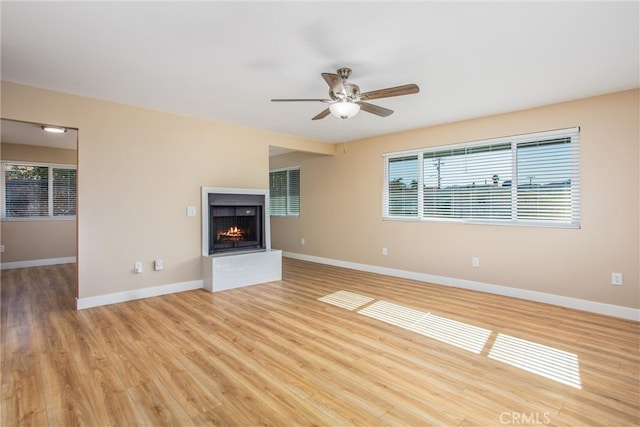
[489,334,582,389]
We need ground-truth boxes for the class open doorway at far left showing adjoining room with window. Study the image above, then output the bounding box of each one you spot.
[0,119,78,305]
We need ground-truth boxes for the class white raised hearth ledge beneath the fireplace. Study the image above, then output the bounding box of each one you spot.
[202,249,282,292]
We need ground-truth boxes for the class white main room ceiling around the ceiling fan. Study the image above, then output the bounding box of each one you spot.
[1,1,640,149]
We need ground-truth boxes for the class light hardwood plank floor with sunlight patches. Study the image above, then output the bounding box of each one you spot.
[0,258,640,426]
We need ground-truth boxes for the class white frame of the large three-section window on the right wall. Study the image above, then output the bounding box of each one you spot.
[382,127,580,229]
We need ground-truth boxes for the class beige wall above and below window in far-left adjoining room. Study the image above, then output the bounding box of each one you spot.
[0,143,77,264]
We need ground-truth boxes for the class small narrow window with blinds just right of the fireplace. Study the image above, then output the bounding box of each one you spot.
[269,167,300,216]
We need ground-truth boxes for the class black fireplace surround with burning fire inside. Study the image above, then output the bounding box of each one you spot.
[209,193,265,255]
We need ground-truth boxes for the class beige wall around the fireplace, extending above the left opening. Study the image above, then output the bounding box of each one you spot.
[2,82,333,298]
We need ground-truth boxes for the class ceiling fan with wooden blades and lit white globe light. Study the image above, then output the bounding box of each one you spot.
[271,68,420,120]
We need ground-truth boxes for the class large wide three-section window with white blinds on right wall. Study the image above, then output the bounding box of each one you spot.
[383,128,580,228]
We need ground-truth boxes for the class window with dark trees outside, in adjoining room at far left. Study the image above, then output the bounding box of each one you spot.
[2,162,76,219]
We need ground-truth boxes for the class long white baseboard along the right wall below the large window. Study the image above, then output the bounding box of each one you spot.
[282,252,640,321]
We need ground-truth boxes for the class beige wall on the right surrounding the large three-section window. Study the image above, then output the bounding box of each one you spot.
[271,90,640,308]
